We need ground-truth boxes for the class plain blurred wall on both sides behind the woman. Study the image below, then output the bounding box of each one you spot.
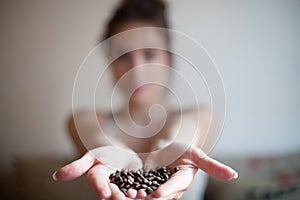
[0,0,300,169]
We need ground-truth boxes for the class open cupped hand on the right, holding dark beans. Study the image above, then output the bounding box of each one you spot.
[145,143,238,199]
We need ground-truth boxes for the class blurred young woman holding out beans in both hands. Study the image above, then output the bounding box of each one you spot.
[53,0,237,199]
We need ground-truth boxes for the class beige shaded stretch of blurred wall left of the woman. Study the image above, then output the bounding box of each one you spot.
[0,0,116,168]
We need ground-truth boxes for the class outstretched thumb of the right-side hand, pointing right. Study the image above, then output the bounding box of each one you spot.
[192,148,238,180]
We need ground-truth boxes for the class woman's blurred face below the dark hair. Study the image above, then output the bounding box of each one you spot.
[110,22,171,106]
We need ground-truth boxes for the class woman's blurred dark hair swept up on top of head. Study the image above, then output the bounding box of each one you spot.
[103,0,169,40]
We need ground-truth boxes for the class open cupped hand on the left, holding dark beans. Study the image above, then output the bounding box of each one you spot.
[53,146,146,200]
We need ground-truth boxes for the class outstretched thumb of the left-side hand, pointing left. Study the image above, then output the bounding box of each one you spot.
[52,153,95,181]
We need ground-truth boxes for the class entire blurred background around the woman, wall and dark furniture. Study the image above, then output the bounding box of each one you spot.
[0,0,300,200]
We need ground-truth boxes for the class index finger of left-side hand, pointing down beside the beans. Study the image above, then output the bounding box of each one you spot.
[87,165,112,199]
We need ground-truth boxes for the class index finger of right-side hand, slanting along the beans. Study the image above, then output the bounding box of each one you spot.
[152,167,197,198]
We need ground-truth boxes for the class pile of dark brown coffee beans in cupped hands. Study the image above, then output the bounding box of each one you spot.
[109,167,178,194]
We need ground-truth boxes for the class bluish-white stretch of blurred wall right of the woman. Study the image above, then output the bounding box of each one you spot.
[171,0,300,155]
